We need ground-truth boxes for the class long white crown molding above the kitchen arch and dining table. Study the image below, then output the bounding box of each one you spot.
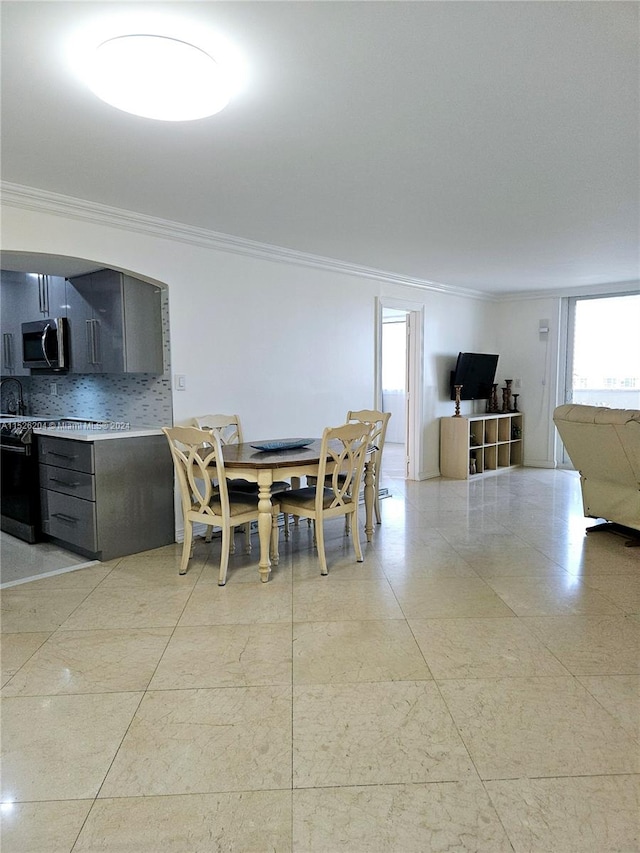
[0,181,495,301]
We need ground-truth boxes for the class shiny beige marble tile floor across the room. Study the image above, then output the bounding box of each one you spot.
[0,469,640,853]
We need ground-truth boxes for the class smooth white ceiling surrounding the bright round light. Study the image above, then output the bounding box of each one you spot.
[2,0,640,293]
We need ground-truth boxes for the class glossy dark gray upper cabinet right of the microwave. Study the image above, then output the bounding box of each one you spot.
[66,270,163,374]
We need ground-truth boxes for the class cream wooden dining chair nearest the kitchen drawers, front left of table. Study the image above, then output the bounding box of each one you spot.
[162,427,280,586]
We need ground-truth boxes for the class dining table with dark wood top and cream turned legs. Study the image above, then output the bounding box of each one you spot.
[222,438,375,583]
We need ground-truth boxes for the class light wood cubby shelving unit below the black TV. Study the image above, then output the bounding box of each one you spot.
[440,412,523,480]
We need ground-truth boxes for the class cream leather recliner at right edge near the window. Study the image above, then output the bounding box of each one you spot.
[553,404,640,545]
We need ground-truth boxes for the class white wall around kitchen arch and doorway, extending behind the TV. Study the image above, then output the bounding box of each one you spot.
[2,200,536,477]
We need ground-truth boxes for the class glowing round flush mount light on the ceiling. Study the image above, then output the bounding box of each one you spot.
[87,34,233,121]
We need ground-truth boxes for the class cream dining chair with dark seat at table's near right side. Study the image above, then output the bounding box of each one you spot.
[278,423,371,575]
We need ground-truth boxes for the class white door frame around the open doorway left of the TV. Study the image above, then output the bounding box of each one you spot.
[375,296,424,480]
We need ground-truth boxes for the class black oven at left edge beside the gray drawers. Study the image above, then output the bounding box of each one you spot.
[0,421,40,542]
